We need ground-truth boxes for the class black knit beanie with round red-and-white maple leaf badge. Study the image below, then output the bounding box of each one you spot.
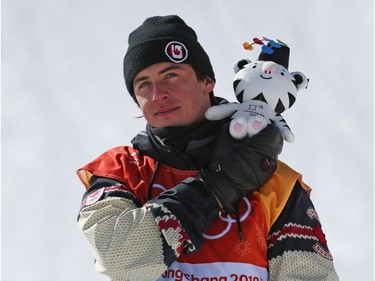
[124,15,215,102]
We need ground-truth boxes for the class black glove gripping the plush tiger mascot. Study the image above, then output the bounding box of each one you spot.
[198,124,283,213]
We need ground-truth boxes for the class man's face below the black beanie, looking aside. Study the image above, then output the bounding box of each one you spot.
[133,62,215,128]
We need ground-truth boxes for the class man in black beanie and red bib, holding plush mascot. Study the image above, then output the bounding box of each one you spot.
[78,16,338,281]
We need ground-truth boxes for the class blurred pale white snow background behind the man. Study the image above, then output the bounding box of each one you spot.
[1,0,374,281]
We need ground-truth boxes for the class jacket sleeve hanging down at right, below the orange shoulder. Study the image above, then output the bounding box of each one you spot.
[267,181,339,281]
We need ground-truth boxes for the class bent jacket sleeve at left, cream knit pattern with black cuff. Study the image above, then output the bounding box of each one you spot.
[78,178,218,281]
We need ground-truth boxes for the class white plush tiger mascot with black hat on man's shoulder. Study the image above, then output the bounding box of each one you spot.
[206,42,308,142]
